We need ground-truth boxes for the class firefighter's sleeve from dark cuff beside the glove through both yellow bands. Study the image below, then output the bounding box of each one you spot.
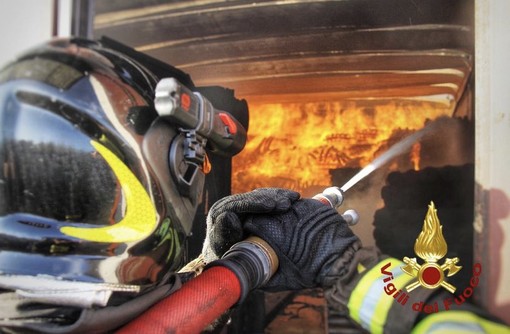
[325,258,510,334]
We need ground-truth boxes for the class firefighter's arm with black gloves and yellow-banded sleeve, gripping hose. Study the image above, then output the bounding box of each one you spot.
[203,189,508,334]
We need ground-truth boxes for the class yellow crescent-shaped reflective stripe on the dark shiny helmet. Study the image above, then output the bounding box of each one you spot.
[60,140,157,243]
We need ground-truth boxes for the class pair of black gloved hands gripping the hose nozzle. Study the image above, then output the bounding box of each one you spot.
[204,189,360,290]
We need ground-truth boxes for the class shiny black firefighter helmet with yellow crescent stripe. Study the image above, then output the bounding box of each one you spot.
[0,39,204,318]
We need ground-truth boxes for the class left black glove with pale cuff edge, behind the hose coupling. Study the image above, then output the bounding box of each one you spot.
[202,188,300,263]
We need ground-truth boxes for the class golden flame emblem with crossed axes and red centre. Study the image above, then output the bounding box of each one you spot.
[402,202,462,293]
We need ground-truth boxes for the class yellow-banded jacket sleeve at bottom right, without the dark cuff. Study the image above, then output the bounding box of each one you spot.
[347,258,510,334]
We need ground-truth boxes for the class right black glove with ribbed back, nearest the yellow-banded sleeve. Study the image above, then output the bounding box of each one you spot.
[244,199,359,290]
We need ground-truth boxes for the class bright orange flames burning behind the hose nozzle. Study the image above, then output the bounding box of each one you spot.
[232,101,452,196]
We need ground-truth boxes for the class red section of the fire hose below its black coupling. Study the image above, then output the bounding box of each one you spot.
[118,266,241,334]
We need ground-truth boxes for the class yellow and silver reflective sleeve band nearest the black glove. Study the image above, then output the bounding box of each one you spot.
[348,258,412,333]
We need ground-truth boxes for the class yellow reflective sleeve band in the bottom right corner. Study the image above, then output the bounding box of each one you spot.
[412,310,510,334]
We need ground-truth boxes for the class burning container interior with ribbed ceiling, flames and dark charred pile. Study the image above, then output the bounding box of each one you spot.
[93,0,474,324]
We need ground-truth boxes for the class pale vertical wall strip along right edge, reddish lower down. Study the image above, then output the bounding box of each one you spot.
[475,0,510,324]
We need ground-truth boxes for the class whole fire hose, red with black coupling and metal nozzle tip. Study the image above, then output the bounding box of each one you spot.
[118,187,352,334]
